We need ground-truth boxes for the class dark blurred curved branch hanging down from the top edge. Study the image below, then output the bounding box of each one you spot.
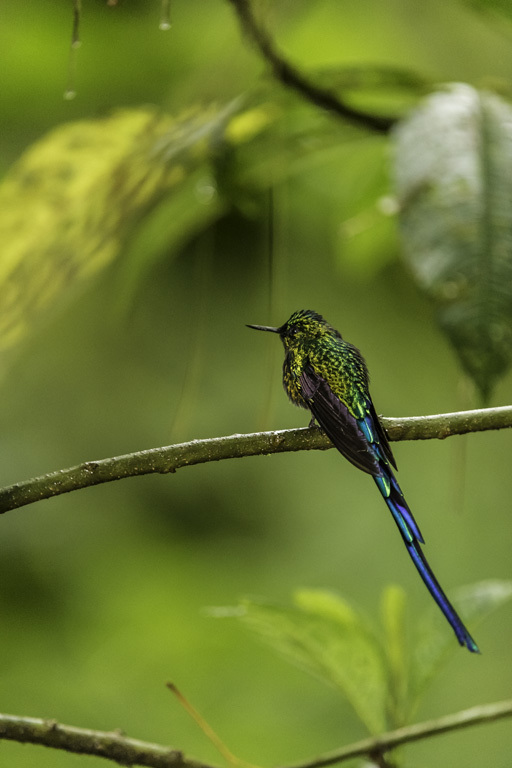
[228,0,396,133]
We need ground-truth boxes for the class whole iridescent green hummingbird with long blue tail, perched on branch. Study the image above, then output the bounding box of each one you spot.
[249,310,478,652]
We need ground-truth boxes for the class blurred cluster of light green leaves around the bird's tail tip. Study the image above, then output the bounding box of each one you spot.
[225,581,512,735]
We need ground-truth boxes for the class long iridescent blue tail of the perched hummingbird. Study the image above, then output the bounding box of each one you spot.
[373,462,480,653]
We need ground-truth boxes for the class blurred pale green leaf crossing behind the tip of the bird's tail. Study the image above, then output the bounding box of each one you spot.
[411,580,512,704]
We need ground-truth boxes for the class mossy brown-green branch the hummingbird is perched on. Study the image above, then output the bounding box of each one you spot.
[0,406,512,513]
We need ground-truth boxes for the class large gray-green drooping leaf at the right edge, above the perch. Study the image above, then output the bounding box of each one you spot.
[395,84,512,399]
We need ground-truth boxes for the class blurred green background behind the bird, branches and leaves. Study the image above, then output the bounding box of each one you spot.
[0,0,512,768]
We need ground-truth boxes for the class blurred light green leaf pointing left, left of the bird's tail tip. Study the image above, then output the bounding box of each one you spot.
[236,590,387,733]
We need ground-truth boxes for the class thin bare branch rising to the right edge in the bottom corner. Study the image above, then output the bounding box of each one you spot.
[278,699,512,768]
